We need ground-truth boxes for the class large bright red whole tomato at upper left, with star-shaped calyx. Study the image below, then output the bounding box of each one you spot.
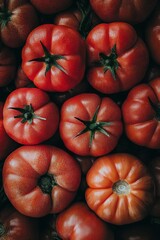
[22,24,86,92]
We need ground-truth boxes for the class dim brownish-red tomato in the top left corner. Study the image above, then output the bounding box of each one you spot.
[0,0,39,48]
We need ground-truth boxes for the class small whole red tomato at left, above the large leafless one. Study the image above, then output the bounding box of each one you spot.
[3,88,59,145]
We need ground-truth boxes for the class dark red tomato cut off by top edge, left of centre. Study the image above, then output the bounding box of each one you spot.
[30,0,73,14]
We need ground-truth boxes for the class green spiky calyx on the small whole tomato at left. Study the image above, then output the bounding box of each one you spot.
[9,104,46,124]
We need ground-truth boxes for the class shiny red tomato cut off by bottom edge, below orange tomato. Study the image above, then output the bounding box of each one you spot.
[56,202,114,240]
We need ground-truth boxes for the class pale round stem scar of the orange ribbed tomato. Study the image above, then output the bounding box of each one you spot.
[112,180,130,195]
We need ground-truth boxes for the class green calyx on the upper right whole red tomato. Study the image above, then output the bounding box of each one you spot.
[98,44,119,80]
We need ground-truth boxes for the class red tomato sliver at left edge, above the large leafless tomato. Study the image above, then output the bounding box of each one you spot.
[0,102,16,161]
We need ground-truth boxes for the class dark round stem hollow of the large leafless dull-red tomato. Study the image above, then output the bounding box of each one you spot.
[38,173,56,194]
